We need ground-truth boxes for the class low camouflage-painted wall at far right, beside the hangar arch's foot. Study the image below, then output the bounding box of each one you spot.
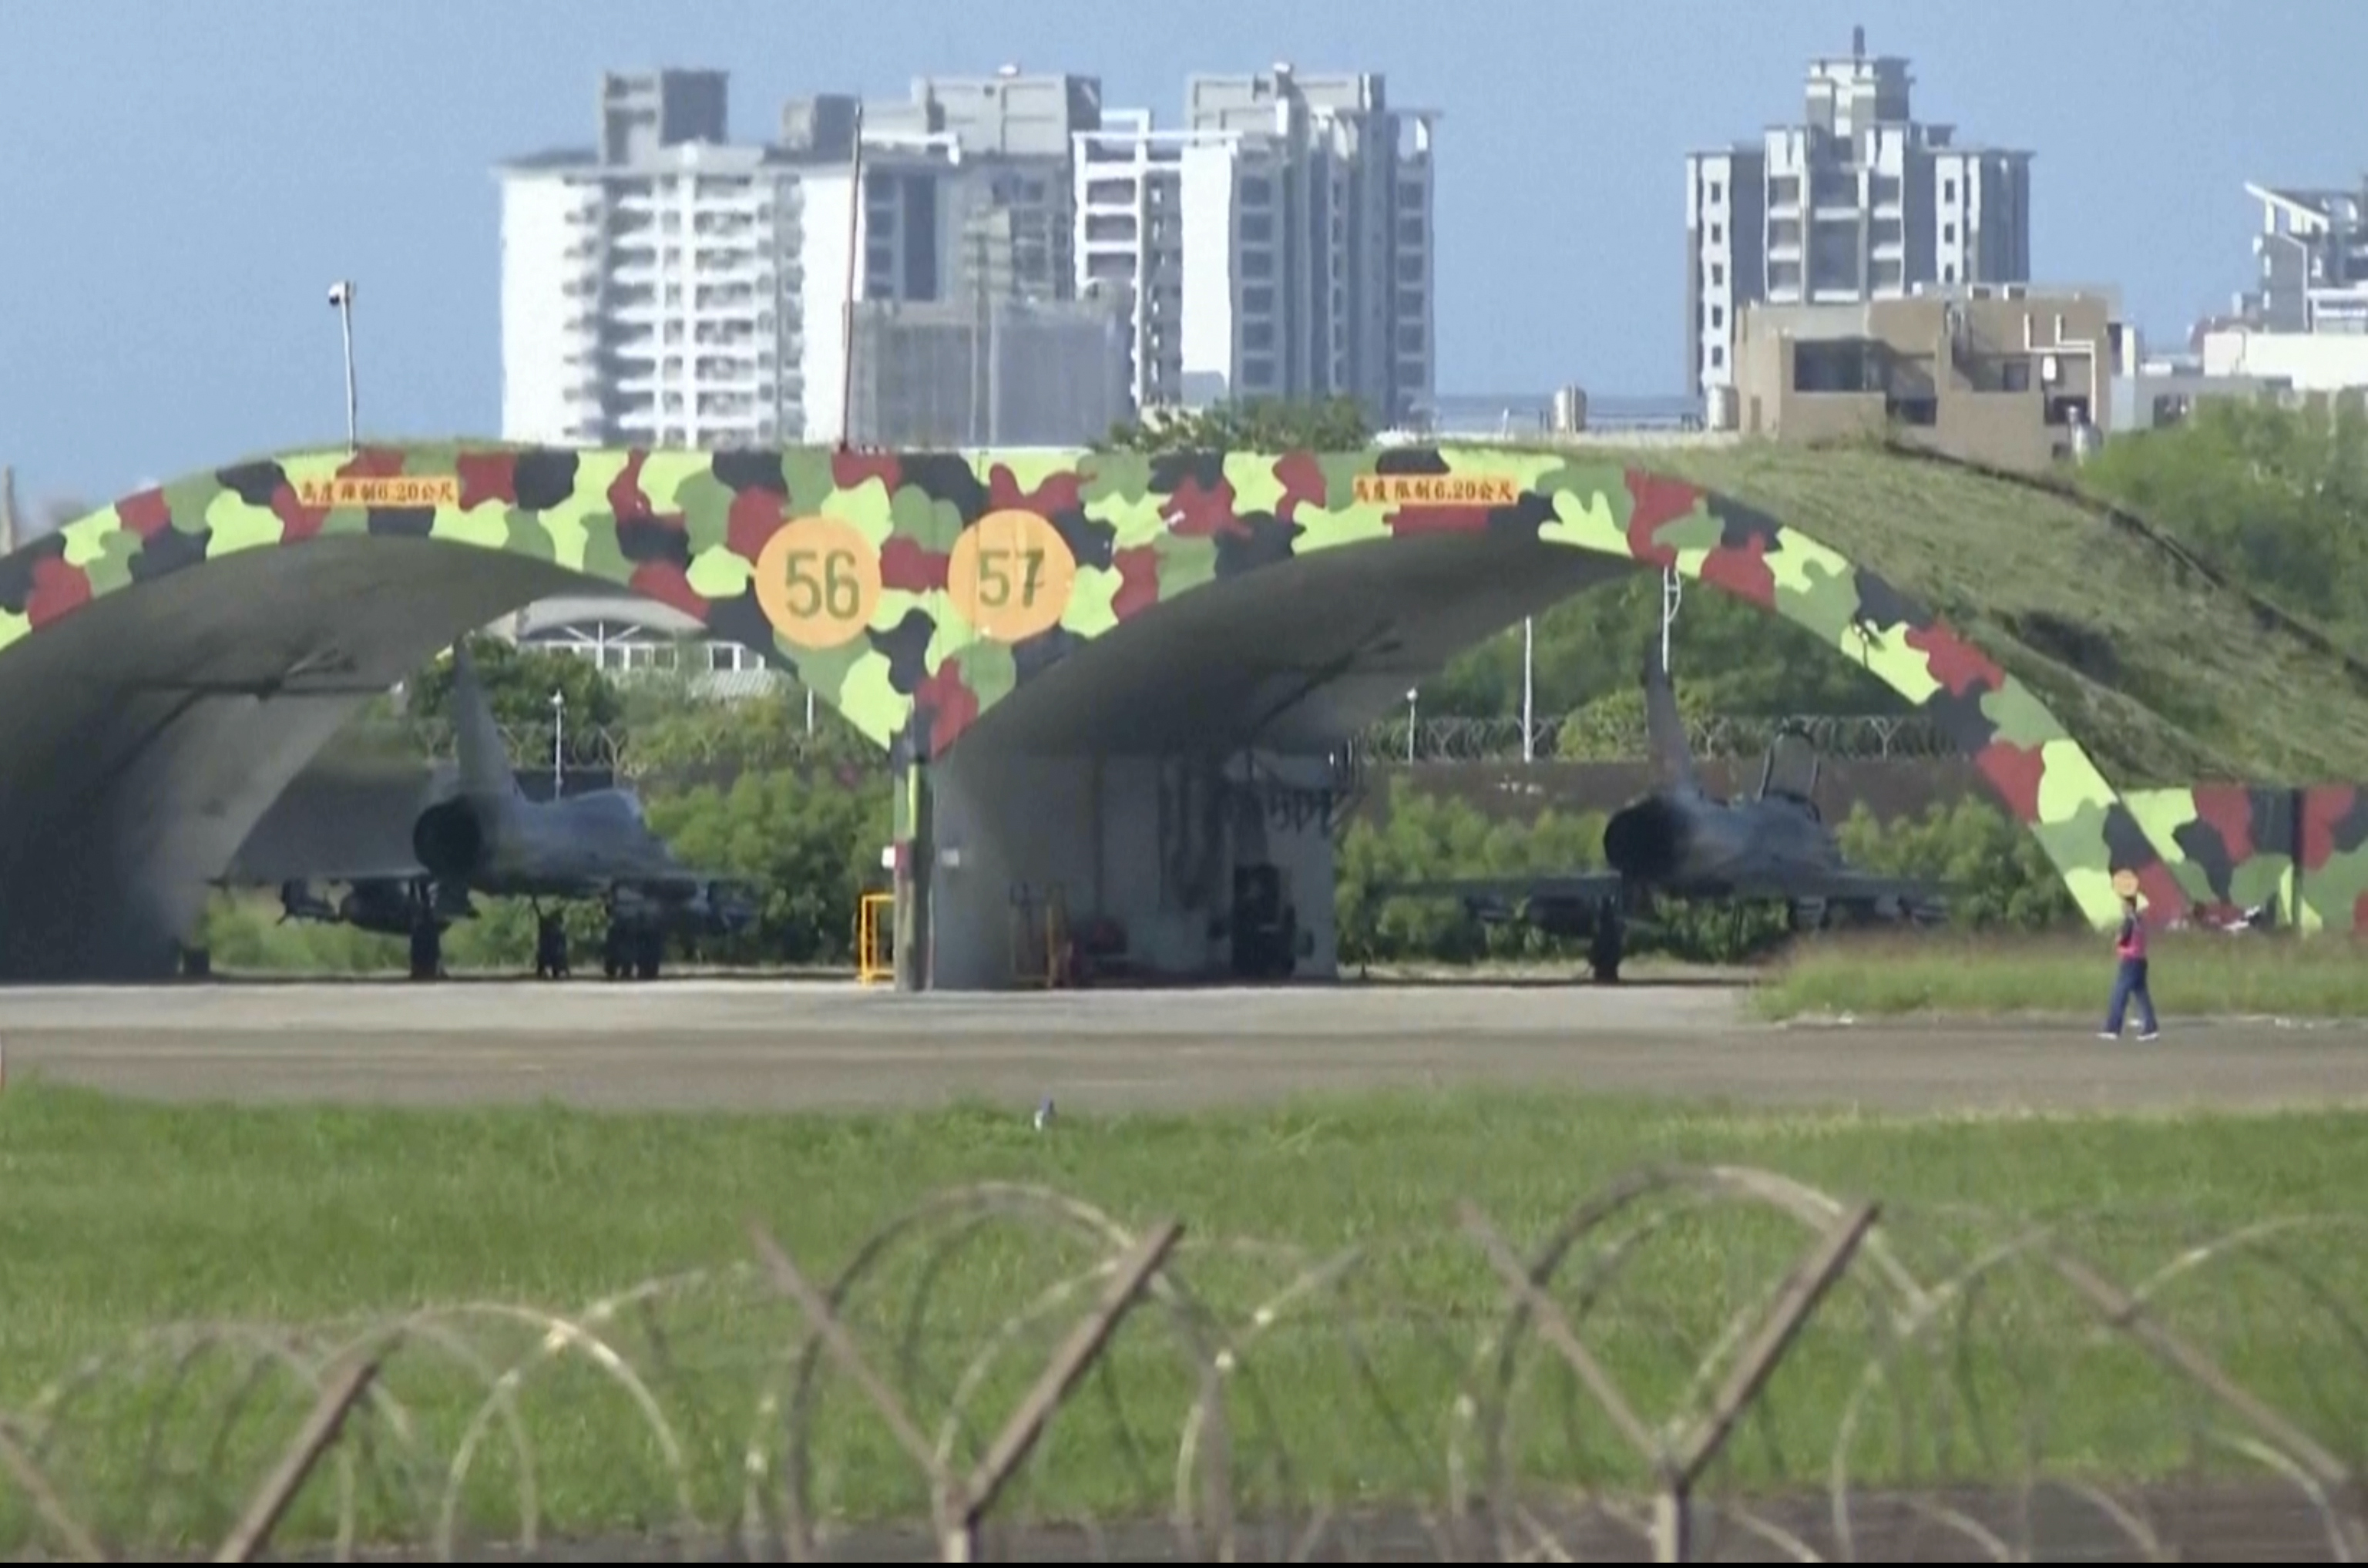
[2127,784,2368,933]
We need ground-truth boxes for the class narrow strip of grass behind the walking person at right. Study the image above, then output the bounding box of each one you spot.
[1752,933,2368,1021]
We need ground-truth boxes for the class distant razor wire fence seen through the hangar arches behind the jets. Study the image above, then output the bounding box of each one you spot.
[345,713,1958,779]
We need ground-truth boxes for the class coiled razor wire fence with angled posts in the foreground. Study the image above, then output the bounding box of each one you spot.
[0,1165,2368,1561]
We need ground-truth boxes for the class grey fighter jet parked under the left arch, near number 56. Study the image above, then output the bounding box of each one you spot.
[225,646,755,981]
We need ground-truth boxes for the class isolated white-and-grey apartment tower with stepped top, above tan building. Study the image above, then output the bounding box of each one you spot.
[1686,29,2032,405]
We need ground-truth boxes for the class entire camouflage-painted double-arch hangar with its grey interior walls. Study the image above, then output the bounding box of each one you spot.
[0,445,2368,988]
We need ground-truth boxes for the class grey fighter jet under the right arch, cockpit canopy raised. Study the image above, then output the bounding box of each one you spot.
[1375,640,1946,983]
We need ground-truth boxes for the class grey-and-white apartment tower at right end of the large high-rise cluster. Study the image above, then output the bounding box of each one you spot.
[1073,64,1435,424]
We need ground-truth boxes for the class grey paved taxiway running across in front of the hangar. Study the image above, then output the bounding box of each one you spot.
[0,981,2368,1111]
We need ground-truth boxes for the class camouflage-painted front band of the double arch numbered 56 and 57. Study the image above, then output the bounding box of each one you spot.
[0,445,2183,924]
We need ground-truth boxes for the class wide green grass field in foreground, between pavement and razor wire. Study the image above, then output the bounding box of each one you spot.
[0,1083,2368,1549]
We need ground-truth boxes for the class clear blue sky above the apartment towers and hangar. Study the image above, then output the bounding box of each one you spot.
[0,0,2368,505]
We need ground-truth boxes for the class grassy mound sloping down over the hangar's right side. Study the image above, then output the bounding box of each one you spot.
[1629,443,2368,789]
